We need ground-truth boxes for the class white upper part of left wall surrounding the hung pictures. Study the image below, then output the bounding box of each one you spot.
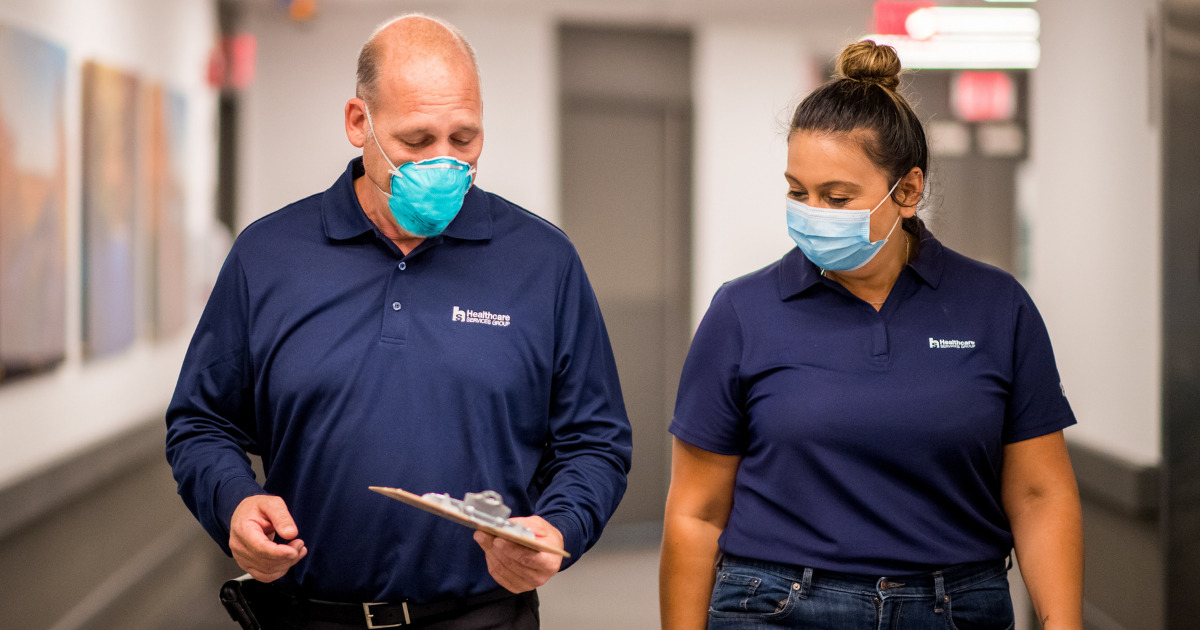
[0,0,216,487]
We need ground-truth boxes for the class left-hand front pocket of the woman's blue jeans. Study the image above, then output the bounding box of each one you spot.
[708,563,799,618]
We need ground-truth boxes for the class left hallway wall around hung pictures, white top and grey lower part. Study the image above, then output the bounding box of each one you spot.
[0,0,235,630]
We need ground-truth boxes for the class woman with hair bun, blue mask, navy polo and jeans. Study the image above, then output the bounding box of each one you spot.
[660,41,1082,630]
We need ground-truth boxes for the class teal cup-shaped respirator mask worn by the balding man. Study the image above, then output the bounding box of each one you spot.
[366,109,475,238]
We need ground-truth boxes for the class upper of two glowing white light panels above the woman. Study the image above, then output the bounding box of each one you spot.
[905,6,1042,40]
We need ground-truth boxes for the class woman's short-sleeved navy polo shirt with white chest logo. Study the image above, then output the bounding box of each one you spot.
[671,226,1075,575]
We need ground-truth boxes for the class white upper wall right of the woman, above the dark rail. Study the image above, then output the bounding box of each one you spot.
[1026,0,1162,464]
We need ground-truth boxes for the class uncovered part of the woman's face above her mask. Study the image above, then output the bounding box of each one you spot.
[784,131,916,241]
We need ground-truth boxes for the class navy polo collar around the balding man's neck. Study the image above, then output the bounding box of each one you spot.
[320,157,492,240]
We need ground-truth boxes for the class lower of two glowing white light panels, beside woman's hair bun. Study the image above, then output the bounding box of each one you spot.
[863,35,1042,70]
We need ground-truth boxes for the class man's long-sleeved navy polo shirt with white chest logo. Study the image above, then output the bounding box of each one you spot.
[167,158,631,602]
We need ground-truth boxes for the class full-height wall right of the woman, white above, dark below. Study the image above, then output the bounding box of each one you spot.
[1022,0,1166,630]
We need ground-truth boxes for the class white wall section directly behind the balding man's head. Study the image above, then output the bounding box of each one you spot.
[239,4,559,227]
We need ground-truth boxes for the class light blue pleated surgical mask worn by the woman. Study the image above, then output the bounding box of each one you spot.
[787,180,900,271]
